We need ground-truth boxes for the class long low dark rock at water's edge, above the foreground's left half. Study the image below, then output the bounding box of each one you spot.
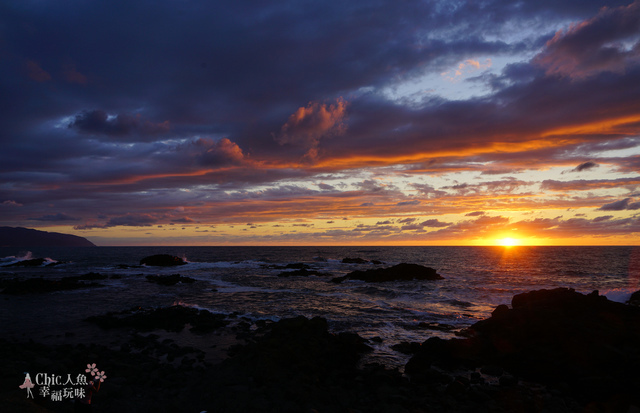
[85,305,228,333]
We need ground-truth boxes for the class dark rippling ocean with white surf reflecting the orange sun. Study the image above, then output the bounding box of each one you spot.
[0,246,640,366]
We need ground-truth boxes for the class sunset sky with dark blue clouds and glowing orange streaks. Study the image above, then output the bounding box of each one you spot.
[0,0,640,246]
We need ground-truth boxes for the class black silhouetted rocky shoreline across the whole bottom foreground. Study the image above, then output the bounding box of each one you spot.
[0,288,640,413]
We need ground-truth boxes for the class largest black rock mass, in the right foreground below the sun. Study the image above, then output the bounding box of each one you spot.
[405,288,640,406]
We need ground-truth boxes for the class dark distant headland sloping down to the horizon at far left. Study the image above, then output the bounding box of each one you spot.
[0,227,96,247]
